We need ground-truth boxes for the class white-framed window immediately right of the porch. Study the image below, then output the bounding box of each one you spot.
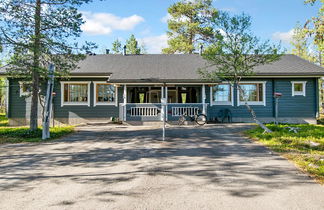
[210,84,233,106]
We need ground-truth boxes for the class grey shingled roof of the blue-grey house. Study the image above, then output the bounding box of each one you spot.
[72,54,324,81]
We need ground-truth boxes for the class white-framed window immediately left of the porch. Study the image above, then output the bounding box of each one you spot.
[94,82,117,106]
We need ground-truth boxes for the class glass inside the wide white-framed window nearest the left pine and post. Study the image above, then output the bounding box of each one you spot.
[64,84,88,102]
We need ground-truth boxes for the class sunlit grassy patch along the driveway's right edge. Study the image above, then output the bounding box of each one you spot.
[245,124,324,184]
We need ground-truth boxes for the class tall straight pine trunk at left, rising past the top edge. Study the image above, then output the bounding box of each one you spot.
[30,0,41,130]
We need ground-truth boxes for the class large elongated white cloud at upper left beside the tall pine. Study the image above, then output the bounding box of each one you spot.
[81,12,144,35]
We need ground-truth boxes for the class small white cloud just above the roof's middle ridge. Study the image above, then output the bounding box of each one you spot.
[139,34,168,54]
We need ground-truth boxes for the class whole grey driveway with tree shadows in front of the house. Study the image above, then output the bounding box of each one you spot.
[0,125,324,210]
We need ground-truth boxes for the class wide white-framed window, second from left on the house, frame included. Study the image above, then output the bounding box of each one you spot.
[61,82,90,106]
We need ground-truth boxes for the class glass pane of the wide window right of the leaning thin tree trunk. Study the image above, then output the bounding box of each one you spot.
[240,84,263,101]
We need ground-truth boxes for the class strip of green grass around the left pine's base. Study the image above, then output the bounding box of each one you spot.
[0,126,74,144]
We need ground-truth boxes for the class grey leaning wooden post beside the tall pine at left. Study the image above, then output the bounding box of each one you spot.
[42,64,54,140]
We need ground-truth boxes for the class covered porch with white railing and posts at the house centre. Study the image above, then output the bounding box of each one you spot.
[119,84,207,121]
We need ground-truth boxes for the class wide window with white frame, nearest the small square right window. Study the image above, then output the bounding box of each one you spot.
[238,82,266,106]
